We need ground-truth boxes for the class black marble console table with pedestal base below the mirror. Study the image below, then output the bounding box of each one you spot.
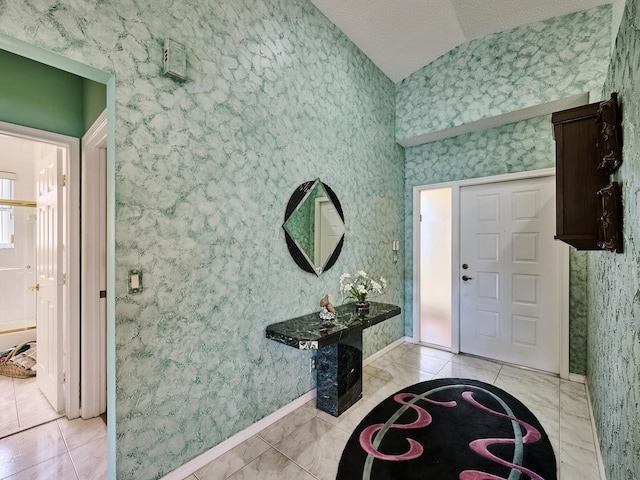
[266,302,400,417]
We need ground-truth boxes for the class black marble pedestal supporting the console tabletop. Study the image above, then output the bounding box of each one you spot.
[316,330,362,417]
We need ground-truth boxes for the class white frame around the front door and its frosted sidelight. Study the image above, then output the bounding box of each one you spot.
[412,168,569,379]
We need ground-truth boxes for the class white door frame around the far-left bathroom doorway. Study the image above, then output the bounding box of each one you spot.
[0,118,80,419]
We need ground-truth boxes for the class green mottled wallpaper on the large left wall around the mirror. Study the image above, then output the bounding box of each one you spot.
[0,0,404,480]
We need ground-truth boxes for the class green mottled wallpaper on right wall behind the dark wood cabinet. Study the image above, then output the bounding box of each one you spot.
[587,0,640,480]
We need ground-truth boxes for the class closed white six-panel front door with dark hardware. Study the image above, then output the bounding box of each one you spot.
[459,177,561,373]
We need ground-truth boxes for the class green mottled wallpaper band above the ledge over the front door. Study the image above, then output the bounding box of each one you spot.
[396,5,611,140]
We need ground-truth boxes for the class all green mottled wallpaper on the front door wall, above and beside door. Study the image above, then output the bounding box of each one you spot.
[396,6,611,374]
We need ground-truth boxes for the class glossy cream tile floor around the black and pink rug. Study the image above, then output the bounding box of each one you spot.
[185,343,600,480]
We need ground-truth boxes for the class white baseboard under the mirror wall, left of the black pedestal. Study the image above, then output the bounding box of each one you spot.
[162,388,316,480]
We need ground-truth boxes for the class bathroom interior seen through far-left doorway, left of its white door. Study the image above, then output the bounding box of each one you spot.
[0,130,62,437]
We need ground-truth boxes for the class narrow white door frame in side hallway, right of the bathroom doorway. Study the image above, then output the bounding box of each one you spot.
[80,110,107,419]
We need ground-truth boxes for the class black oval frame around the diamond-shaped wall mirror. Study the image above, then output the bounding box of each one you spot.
[282,179,346,277]
